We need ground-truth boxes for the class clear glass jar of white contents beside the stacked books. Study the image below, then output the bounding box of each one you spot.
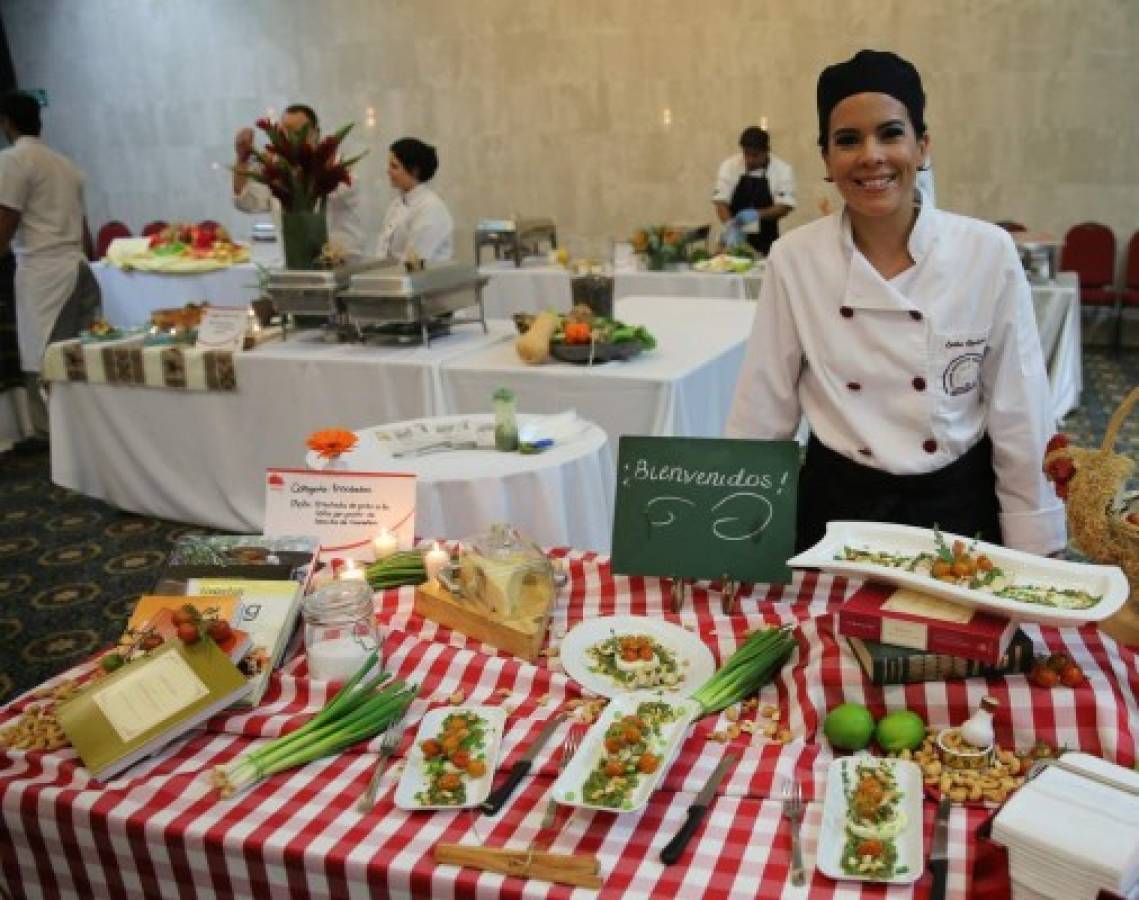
[301,579,383,681]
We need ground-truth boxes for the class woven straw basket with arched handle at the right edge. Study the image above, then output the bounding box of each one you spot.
[1044,387,1139,595]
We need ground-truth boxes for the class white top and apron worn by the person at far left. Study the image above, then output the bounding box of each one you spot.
[0,136,85,371]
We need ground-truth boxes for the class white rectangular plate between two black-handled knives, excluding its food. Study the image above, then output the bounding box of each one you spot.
[552,690,700,812]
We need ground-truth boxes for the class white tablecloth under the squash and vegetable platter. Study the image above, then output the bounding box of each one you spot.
[442,297,755,453]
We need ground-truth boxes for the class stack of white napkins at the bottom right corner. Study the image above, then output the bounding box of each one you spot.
[992,753,1139,900]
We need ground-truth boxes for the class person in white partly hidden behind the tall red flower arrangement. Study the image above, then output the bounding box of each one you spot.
[233,104,366,261]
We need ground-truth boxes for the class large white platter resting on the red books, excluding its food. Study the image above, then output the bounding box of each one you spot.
[787,522,1131,628]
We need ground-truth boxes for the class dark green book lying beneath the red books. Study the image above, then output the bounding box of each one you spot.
[846,629,1035,685]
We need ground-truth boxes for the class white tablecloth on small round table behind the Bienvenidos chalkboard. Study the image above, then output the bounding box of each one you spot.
[306,415,615,553]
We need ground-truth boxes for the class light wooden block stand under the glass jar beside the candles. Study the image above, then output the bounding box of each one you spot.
[415,581,557,662]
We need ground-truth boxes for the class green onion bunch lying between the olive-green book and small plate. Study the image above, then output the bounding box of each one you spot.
[212,651,418,797]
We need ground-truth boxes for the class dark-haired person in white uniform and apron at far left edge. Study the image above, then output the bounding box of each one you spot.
[0,91,101,449]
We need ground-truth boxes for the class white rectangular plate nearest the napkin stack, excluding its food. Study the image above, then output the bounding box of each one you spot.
[818,755,925,884]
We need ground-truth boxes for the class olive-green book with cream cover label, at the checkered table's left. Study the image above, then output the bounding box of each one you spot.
[56,638,253,778]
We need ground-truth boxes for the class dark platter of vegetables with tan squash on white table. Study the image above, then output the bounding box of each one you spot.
[514,303,656,366]
